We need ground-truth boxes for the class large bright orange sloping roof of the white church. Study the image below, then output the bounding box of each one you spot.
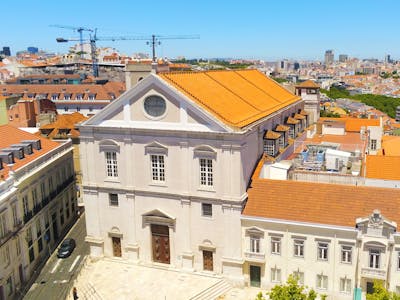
[159,70,301,128]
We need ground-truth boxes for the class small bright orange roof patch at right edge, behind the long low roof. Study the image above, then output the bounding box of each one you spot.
[365,155,400,180]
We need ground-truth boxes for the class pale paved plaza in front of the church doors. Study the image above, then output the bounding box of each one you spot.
[68,259,260,300]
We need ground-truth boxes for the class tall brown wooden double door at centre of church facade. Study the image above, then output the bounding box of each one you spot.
[151,224,171,264]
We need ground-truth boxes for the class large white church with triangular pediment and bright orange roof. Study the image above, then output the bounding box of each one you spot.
[79,70,307,285]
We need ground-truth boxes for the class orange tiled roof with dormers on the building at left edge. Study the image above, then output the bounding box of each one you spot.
[0,125,60,178]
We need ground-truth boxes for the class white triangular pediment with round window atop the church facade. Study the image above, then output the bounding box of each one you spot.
[83,74,232,132]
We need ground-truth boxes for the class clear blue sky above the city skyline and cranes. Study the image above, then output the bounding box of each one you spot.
[0,0,400,60]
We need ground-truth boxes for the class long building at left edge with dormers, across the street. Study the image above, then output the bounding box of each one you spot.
[0,125,77,299]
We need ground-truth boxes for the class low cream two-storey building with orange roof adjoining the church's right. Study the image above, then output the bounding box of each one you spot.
[241,169,400,299]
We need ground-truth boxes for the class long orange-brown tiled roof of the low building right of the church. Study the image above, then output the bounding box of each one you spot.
[243,178,400,228]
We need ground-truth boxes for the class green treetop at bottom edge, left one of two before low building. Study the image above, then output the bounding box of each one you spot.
[256,275,318,300]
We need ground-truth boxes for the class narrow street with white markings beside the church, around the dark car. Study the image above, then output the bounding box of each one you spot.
[24,214,89,300]
